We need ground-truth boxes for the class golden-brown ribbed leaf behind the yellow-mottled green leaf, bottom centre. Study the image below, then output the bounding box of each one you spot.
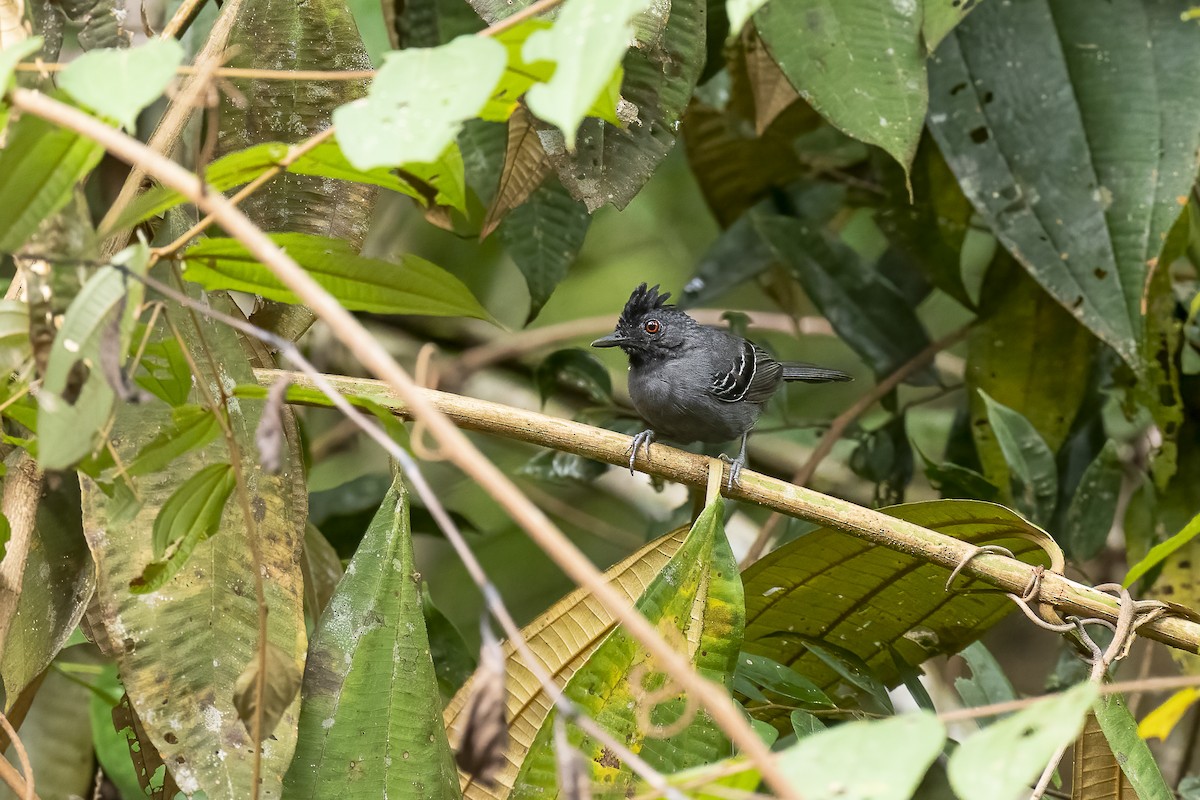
[444,528,688,799]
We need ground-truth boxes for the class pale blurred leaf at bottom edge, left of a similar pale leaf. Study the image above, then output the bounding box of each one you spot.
[778,711,945,800]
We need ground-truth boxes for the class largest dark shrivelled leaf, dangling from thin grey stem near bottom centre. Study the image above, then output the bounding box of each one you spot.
[455,619,509,787]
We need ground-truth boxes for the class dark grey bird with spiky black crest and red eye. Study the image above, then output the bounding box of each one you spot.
[592,283,852,487]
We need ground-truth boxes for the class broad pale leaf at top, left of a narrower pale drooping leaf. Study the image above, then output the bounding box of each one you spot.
[334,36,506,169]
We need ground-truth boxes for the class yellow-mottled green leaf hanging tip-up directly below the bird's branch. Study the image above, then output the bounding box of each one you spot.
[509,498,745,800]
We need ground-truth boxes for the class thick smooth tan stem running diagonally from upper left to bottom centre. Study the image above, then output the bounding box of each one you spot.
[8,90,806,800]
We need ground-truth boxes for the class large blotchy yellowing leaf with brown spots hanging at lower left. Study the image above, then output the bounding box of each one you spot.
[83,296,307,798]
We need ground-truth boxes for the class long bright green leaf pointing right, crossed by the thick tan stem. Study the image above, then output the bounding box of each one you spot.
[182,234,490,319]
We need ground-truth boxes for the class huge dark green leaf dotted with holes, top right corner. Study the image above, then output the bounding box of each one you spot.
[929,0,1200,367]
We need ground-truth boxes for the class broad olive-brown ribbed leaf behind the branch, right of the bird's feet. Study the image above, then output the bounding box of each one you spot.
[742,500,1057,730]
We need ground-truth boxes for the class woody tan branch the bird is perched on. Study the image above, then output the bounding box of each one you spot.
[256,369,1200,652]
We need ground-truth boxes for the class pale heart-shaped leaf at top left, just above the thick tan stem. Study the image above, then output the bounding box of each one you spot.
[59,38,184,131]
